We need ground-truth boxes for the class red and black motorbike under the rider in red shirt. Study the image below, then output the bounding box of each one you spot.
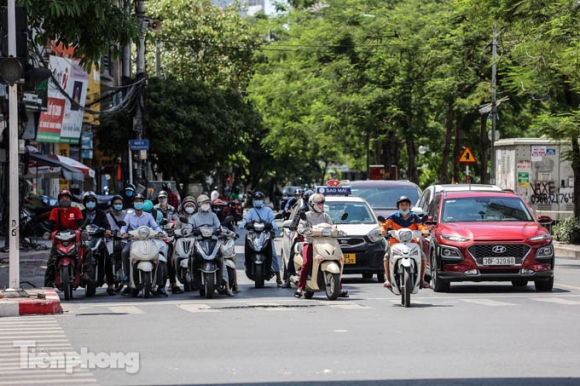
[51,230,89,300]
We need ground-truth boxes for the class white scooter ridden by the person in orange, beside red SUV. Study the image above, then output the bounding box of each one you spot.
[389,228,422,307]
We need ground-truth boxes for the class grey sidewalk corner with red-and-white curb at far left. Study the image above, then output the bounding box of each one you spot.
[0,238,62,317]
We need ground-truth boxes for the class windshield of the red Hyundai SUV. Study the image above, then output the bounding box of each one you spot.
[441,197,534,222]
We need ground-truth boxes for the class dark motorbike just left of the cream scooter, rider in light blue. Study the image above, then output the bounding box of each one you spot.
[244,221,274,288]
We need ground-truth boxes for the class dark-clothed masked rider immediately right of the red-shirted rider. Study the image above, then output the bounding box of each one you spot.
[82,191,115,295]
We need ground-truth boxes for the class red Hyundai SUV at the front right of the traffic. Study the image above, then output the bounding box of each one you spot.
[423,191,554,292]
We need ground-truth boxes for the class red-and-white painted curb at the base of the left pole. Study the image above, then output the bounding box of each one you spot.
[0,289,62,317]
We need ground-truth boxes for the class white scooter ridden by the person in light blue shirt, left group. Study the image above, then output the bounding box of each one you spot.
[129,226,161,298]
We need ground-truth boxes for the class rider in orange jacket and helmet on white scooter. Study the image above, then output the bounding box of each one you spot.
[381,196,429,288]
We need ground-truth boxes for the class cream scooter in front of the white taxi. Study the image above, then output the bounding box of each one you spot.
[290,219,344,300]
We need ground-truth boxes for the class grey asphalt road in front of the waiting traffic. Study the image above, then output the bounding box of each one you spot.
[0,231,580,385]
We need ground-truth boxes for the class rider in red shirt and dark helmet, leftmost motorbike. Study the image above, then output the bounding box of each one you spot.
[44,188,92,287]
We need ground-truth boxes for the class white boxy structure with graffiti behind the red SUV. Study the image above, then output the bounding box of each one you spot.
[494,138,574,220]
